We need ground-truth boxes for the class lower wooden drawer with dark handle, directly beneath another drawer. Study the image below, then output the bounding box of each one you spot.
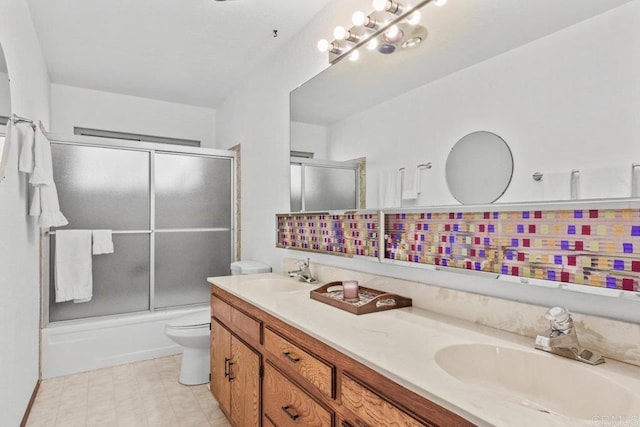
[263,362,333,427]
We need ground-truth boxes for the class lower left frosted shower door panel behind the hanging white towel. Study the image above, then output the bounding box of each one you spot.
[49,234,150,322]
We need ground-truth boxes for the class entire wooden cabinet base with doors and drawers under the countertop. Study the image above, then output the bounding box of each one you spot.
[211,285,473,427]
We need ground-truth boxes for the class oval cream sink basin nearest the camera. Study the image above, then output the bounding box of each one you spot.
[435,344,640,420]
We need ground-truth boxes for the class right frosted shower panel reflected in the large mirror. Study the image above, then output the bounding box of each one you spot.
[304,165,356,211]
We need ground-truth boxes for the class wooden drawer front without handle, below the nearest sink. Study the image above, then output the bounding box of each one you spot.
[340,374,426,427]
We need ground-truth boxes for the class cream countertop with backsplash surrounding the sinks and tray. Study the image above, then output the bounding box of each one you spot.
[209,270,640,426]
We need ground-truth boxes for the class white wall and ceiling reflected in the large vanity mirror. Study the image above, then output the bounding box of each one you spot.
[291,0,640,209]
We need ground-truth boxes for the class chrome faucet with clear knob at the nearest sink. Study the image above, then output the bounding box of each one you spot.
[535,307,604,365]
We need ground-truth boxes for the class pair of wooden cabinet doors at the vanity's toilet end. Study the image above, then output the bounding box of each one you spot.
[211,320,260,426]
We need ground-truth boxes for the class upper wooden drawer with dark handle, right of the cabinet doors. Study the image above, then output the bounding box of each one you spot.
[264,328,334,398]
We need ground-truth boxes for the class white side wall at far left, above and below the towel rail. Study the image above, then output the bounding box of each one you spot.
[0,0,49,426]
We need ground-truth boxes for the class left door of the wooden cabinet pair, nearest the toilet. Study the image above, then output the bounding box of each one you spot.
[211,321,231,414]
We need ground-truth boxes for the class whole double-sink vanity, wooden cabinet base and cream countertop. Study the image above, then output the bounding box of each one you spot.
[209,273,640,426]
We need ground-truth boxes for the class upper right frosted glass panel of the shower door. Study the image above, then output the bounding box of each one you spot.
[155,153,231,228]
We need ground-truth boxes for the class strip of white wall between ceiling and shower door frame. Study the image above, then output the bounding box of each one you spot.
[50,84,218,148]
